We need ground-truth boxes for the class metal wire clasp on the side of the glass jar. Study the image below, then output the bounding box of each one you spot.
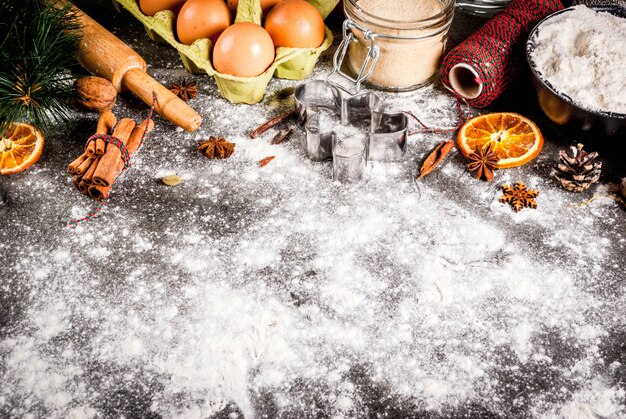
[326,19,380,93]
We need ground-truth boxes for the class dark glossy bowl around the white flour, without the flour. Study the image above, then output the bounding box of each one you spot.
[526,6,626,136]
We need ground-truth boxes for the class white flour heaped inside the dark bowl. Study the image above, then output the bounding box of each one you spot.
[533,6,626,113]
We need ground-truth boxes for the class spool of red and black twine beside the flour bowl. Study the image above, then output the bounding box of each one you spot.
[441,0,563,108]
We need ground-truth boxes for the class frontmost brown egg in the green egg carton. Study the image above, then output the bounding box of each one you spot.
[213,22,276,77]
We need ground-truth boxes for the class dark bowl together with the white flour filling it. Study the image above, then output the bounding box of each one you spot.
[526,6,626,136]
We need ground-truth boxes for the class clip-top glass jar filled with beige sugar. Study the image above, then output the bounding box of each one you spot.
[342,0,455,91]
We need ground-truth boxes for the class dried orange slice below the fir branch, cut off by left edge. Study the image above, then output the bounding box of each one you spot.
[0,123,43,175]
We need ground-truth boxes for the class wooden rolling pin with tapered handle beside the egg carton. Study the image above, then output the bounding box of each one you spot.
[67,2,202,131]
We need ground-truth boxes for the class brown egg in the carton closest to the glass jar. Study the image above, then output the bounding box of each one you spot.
[265,0,325,48]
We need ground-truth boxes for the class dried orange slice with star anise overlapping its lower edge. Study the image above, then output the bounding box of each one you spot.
[457,112,543,169]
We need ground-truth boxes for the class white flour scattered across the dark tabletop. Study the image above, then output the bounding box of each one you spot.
[0,74,626,419]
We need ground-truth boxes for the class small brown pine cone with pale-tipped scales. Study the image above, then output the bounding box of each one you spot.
[552,144,602,192]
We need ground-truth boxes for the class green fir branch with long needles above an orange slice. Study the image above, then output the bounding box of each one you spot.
[0,0,80,130]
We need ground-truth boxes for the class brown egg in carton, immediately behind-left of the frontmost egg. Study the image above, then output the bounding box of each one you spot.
[176,0,231,45]
